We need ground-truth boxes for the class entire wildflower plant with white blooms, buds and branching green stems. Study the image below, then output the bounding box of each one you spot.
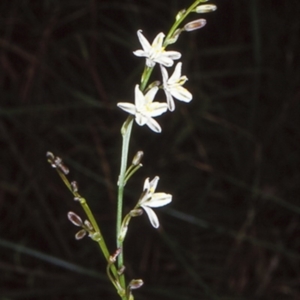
[47,0,216,300]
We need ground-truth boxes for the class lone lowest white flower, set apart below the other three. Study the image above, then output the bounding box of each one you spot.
[139,176,172,228]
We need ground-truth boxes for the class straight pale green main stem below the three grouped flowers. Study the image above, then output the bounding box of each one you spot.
[116,115,134,289]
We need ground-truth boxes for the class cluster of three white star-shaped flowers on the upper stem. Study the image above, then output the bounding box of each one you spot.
[117,30,193,132]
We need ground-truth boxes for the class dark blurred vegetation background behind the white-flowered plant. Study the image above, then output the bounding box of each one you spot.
[0,0,300,300]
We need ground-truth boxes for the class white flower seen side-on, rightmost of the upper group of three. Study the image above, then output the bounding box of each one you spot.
[160,62,193,111]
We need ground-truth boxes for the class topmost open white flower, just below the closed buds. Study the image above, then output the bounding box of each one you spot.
[133,30,181,67]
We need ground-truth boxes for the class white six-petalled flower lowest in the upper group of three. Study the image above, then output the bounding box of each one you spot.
[117,84,168,132]
